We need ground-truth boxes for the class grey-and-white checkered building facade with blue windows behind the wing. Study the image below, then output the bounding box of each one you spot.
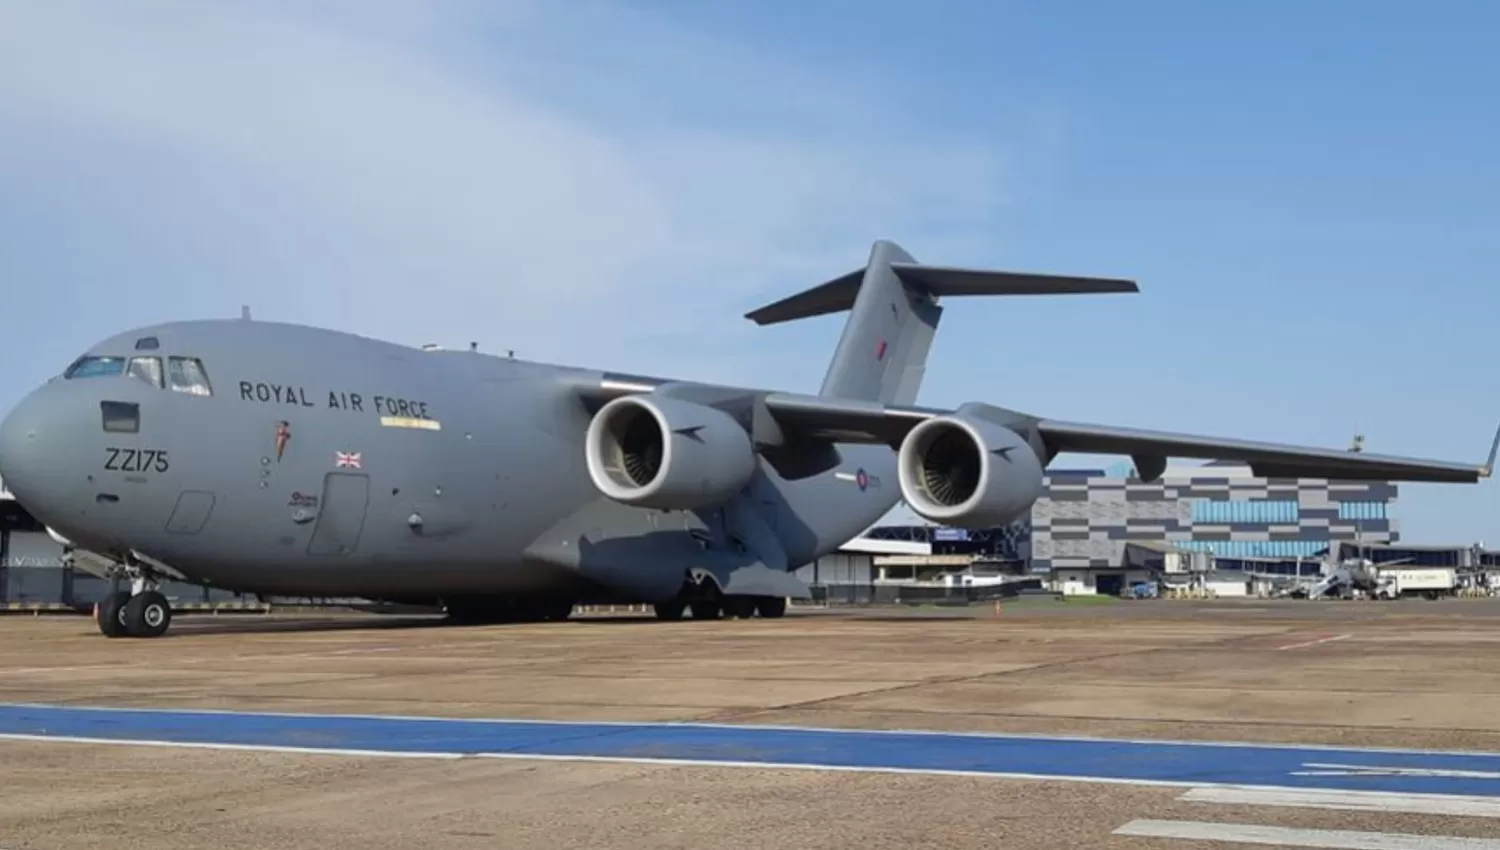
[1031,465,1400,571]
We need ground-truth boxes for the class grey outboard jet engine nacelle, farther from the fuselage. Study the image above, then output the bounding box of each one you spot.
[897,415,1044,528]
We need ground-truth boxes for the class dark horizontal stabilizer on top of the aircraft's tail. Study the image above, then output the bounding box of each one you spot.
[746,253,1140,325]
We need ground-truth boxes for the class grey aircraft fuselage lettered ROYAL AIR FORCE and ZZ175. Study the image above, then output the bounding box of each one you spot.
[8,321,899,603]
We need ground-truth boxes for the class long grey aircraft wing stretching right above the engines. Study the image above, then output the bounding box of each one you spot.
[765,393,1500,483]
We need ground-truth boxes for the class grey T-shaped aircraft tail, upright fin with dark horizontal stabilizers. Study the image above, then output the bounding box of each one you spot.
[746,240,1139,405]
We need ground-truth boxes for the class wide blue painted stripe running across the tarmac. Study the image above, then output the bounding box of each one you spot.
[0,705,1500,798]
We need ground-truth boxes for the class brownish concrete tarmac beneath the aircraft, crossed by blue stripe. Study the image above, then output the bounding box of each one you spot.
[0,600,1500,850]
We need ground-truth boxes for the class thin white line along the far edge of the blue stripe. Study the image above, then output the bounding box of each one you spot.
[0,703,1500,759]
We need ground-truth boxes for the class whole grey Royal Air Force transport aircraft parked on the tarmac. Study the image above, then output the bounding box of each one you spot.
[0,241,1500,637]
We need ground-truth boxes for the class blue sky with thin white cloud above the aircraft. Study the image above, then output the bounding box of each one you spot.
[0,0,1500,546]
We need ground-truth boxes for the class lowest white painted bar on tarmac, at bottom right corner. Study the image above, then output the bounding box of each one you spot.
[1115,820,1500,850]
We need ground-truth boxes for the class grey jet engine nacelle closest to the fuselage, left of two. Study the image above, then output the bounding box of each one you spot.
[584,396,756,510]
